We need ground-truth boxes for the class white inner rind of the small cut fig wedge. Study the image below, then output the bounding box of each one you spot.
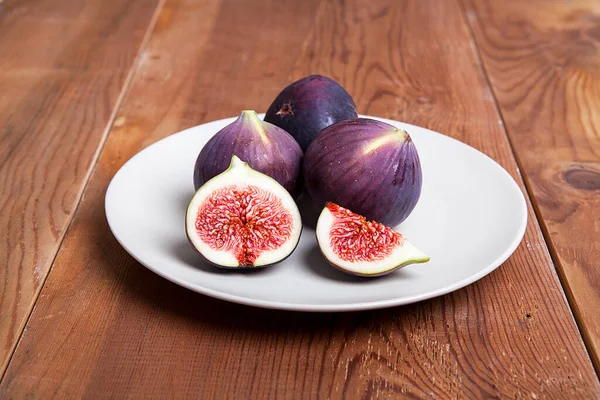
[316,207,429,276]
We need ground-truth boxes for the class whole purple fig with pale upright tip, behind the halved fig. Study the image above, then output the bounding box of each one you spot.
[194,110,303,197]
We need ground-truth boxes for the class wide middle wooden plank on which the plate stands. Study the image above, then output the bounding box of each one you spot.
[0,0,600,399]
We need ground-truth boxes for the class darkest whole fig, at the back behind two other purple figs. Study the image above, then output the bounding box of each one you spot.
[265,75,358,151]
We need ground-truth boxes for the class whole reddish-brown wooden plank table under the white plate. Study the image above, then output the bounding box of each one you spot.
[0,0,600,399]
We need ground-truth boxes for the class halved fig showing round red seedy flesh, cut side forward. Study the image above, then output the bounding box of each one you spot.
[185,156,302,268]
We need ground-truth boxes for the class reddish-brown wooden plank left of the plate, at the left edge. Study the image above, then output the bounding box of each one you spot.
[0,0,157,375]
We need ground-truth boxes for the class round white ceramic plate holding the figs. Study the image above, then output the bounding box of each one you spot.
[105,116,527,311]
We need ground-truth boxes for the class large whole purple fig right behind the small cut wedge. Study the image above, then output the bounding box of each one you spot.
[303,118,423,227]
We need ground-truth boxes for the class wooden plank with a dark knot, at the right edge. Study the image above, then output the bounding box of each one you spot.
[464,0,600,372]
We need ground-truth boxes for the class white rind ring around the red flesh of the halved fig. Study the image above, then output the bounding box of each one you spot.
[186,157,302,267]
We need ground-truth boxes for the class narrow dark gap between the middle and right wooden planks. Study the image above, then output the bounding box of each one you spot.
[457,0,600,377]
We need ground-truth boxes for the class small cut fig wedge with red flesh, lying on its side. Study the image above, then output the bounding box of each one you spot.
[317,203,429,276]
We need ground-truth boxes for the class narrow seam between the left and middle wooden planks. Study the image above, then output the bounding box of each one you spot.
[0,0,166,382]
